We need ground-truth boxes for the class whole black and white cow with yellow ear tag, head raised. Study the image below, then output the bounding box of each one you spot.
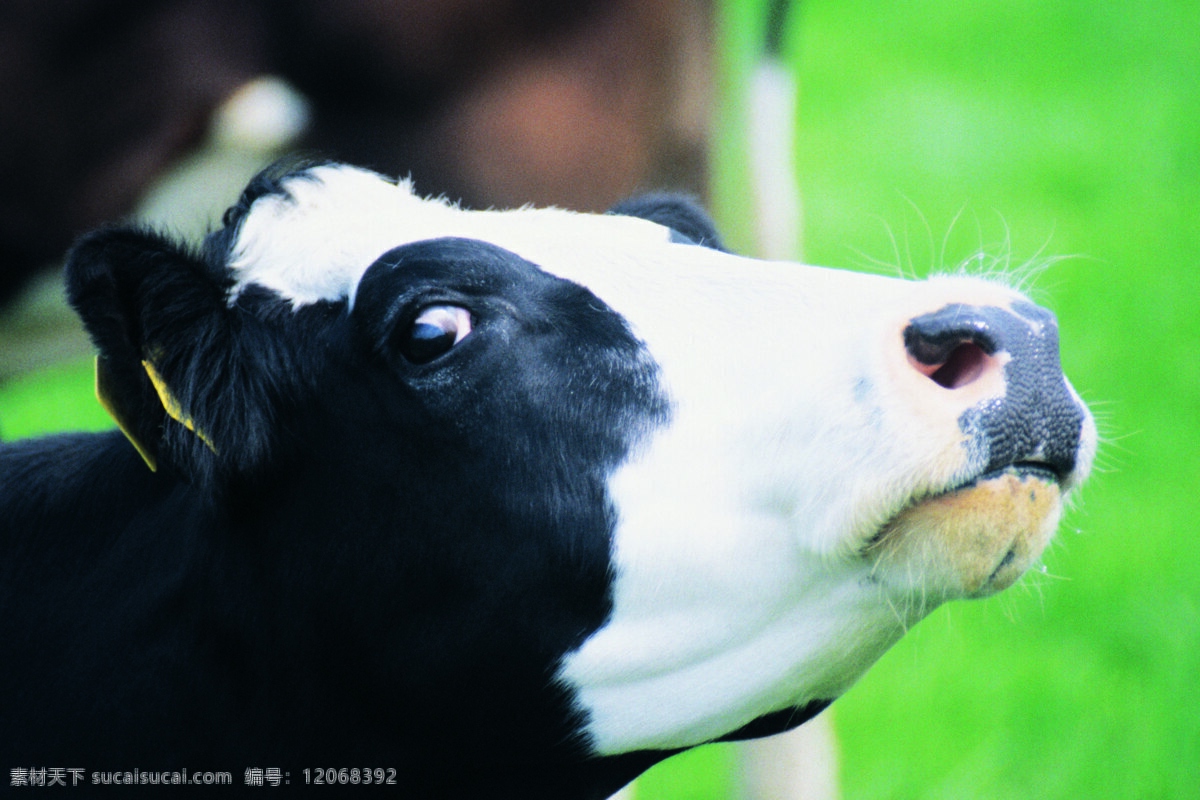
[0,164,1096,798]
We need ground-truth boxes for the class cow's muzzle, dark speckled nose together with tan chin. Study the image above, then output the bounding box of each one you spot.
[865,301,1094,602]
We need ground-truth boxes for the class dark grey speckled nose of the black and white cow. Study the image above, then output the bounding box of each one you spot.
[904,302,1084,481]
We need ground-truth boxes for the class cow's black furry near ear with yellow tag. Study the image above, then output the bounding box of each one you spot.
[66,228,278,489]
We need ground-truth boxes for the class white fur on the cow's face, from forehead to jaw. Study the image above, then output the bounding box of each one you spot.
[226,168,1094,753]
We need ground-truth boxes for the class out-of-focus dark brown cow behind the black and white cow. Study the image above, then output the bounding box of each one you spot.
[0,0,709,300]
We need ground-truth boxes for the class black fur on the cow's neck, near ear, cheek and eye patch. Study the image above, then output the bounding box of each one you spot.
[0,196,686,798]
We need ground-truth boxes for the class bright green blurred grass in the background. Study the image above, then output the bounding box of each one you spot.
[0,0,1200,800]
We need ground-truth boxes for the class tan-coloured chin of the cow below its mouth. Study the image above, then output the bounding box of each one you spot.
[866,465,1062,602]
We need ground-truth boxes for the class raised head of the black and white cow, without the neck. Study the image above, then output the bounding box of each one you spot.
[70,164,1096,782]
